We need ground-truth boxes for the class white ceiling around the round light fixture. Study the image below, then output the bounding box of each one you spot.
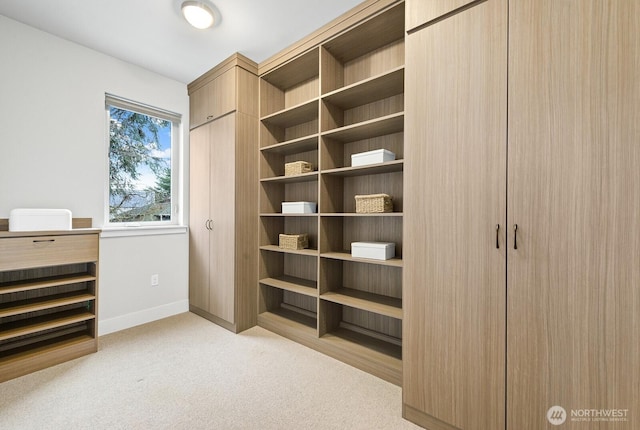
[0,0,362,83]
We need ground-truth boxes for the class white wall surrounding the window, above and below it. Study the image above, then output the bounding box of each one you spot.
[0,16,189,334]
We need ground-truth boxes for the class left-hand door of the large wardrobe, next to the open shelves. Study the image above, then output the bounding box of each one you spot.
[402,0,507,430]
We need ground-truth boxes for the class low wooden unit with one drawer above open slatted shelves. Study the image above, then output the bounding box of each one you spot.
[0,229,99,382]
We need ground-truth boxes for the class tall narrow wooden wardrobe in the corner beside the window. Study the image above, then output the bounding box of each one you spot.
[188,54,258,332]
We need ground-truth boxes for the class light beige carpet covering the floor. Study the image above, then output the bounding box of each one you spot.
[0,313,419,430]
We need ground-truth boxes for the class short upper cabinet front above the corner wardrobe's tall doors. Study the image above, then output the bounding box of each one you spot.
[189,67,241,129]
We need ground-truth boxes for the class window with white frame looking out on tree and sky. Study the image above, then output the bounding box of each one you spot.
[105,94,181,225]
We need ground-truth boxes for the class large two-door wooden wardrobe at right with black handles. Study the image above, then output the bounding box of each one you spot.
[403,0,640,430]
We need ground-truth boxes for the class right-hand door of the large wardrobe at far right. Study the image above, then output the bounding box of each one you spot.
[507,0,640,430]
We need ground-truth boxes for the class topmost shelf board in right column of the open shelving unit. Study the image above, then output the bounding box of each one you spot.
[322,66,404,109]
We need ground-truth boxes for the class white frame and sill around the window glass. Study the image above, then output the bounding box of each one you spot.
[102,93,182,228]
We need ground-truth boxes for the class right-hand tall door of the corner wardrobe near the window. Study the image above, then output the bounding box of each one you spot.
[209,113,236,323]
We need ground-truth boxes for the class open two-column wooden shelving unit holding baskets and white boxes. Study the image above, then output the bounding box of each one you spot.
[258,0,404,384]
